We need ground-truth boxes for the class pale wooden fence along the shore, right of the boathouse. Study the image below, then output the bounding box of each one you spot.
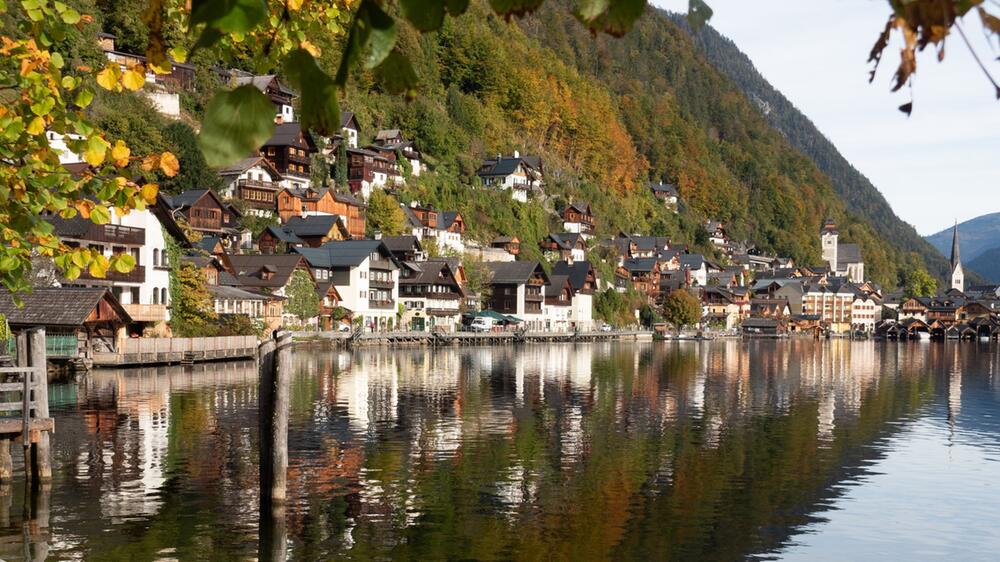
[94,336,257,366]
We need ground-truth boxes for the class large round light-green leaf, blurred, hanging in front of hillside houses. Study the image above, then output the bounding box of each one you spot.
[198,84,274,167]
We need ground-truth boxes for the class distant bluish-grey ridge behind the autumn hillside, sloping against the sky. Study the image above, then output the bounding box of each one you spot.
[670,14,952,278]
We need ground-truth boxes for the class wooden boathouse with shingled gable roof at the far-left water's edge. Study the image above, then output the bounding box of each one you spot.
[0,287,132,358]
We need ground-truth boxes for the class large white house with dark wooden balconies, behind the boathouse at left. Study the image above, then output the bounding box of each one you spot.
[48,208,174,324]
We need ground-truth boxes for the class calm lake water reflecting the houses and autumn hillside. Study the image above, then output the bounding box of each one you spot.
[0,341,1000,560]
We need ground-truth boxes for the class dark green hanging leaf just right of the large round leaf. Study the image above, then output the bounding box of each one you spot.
[285,49,340,136]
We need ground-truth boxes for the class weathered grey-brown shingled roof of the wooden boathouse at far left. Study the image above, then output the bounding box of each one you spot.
[0,287,132,328]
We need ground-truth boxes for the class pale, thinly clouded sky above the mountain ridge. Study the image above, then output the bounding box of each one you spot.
[651,0,1000,235]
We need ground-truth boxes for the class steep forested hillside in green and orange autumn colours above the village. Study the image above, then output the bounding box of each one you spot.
[90,0,914,286]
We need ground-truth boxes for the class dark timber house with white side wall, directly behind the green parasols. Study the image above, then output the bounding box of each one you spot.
[486,261,549,330]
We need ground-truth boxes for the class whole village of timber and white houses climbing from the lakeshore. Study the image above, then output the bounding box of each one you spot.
[3,34,1000,358]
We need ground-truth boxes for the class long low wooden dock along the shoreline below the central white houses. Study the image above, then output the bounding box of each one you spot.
[292,330,653,347]
